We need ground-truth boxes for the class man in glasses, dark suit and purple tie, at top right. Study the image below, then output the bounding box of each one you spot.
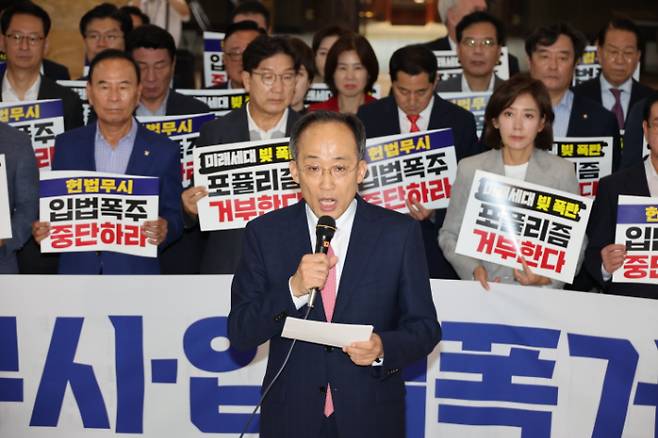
[573,18,652,129]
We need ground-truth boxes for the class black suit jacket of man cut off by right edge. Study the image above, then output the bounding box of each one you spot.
[585,162,658,299]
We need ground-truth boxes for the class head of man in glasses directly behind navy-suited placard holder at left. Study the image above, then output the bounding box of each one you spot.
[80,3,132,69]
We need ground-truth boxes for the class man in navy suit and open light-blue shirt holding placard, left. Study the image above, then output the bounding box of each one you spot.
[32,49,183,274]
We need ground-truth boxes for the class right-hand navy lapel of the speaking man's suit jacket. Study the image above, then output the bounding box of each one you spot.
[332,197,381,321]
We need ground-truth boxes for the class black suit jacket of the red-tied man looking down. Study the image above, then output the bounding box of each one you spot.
[357,94,482,279]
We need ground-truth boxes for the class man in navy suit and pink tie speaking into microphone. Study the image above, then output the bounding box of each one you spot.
[228,111,441,438]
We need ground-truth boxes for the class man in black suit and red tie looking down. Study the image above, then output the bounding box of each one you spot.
[357,44,482,279]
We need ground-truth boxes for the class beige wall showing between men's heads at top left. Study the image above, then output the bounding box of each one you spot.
[35,0,128,79]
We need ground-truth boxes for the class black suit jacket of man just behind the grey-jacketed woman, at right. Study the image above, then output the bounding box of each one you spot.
[567,94,621,172]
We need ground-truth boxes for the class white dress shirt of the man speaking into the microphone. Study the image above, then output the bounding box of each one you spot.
[290,199,356,310]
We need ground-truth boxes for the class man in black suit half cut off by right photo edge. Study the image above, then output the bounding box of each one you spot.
[585,94,658,299]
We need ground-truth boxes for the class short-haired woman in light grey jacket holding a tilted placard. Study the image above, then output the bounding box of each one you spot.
[439,74,578,290]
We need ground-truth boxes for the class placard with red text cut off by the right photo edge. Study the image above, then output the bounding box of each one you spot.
[612,195,658,284]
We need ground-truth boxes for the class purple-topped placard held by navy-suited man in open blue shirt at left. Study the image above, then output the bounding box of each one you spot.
[39,171,159,257]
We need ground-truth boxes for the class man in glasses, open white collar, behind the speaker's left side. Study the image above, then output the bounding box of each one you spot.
[182,35,299,274]
